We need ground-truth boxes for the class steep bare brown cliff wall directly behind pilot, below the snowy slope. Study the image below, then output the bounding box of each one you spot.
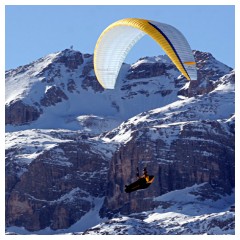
[101,121,235,217]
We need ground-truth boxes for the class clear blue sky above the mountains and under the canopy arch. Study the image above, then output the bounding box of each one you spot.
[5,5,235,69]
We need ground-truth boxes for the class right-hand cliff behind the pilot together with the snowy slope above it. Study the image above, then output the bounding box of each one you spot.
[101,69,235,217]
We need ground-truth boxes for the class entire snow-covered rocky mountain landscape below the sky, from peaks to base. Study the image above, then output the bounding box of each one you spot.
[5,49,235,234]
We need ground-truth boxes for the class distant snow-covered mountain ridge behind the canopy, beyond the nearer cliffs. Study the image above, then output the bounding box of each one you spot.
[6,49,231,131]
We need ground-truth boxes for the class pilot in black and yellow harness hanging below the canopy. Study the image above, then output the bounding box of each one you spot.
[125,168,154,193]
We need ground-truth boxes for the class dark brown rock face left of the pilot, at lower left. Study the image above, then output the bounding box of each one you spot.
[6,131,109,231]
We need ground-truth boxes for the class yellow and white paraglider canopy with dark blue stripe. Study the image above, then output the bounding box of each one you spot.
[94,18,197,89]
